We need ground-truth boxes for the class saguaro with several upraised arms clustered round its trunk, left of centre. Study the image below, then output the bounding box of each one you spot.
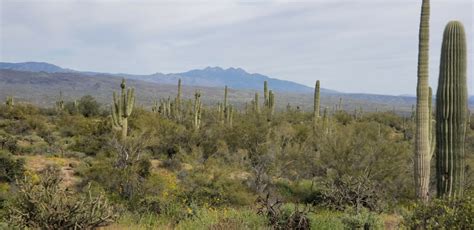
[111,79,135,140]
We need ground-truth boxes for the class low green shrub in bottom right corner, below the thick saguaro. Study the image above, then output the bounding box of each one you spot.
[403,196,474,229]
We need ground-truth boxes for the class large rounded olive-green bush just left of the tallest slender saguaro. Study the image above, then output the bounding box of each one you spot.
[316,122,414,204]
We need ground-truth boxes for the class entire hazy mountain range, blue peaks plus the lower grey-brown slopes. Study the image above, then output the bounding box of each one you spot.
[0,62,474,112]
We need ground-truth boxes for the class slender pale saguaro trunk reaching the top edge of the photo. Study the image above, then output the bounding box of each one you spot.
[414,0,431,202]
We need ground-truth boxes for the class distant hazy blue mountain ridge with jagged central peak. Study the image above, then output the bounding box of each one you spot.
[0,62,337,93]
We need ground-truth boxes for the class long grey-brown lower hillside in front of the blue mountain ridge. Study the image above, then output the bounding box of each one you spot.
[0,69,422,112]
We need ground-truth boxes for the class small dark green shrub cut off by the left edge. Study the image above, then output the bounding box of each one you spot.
[0,150,25,183]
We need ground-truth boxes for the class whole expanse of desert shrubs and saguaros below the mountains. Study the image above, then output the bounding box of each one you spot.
[0,0,474,229]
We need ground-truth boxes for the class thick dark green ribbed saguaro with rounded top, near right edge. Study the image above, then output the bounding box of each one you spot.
[436,21,468,197]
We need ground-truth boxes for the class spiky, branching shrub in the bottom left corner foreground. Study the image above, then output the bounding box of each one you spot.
[6,168,115,229]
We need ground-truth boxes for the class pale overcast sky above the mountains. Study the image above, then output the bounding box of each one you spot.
[0,0,474,95]
